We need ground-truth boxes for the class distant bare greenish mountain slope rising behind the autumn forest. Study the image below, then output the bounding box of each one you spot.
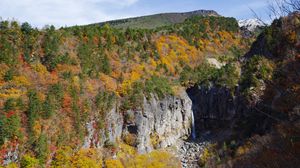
[93,10,220,29]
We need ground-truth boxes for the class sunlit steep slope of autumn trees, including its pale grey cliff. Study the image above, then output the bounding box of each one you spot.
[0,12,252,167]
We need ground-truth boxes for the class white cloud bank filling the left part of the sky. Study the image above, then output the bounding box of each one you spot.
[0,0,138,27]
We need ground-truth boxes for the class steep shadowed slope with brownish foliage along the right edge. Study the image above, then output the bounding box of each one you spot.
[227,12,300,167]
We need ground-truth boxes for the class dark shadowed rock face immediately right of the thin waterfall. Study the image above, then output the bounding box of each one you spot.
[188,86,237,134]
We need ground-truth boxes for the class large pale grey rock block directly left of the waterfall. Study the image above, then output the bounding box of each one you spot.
[125,92,192,153]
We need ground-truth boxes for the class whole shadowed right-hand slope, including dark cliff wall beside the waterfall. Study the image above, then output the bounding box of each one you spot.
[188,12,300,168]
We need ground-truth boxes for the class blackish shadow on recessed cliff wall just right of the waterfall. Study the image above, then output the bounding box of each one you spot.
[187,85,244,141]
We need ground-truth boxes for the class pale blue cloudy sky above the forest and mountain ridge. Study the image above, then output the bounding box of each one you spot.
[0,0,267,28]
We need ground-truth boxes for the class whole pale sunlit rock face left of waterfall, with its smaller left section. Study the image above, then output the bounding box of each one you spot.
[83,92,192,153]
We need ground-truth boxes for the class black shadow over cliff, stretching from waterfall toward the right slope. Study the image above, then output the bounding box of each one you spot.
[187,81,287,142]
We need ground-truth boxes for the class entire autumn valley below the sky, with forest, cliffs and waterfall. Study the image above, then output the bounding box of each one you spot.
[0,7,300,168]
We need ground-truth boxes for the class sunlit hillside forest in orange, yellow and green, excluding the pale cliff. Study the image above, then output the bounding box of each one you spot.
[0,16,252,167]
